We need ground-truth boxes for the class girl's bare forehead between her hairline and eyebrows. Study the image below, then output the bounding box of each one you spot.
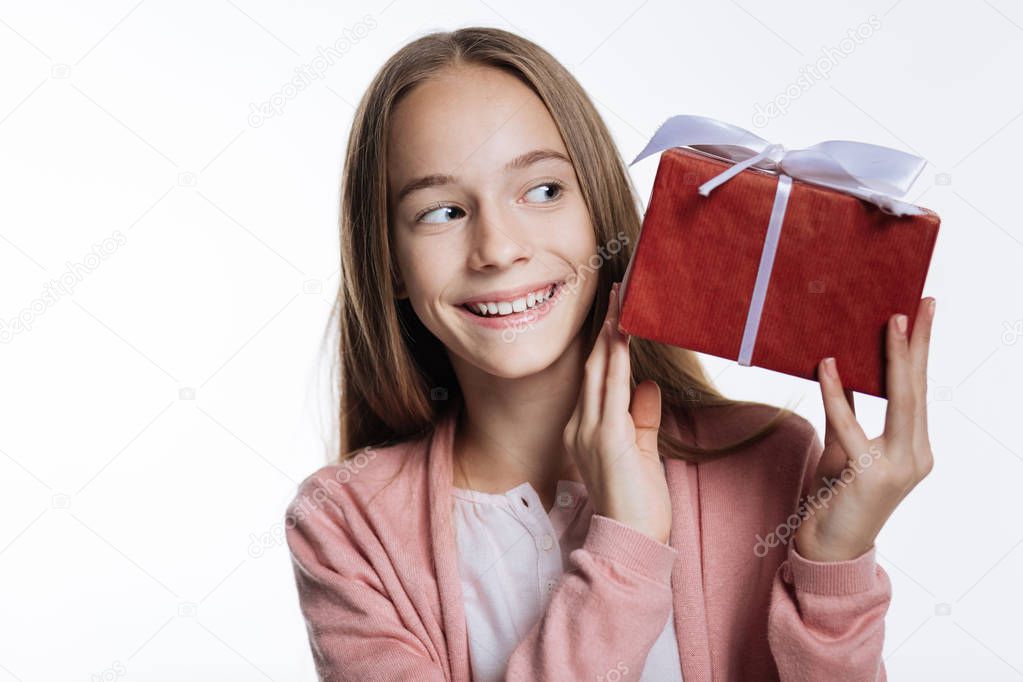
[387,66,568,192]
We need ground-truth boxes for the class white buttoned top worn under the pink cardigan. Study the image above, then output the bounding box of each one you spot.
[452,474,682,682]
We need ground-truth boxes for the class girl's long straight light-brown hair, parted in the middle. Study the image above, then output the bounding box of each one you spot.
[330,28,791,461]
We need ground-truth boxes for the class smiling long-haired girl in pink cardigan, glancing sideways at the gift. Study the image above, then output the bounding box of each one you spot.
[286,28,934,682]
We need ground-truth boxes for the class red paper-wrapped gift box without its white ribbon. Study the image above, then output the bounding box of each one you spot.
[619,134,940,398]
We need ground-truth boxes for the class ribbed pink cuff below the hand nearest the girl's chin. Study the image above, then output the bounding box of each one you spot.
[582,513,678,583]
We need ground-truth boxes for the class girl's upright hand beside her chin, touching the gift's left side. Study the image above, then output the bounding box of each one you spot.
[564,283,671,543]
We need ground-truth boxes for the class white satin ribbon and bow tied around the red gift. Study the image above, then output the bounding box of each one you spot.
[623,115,927,366]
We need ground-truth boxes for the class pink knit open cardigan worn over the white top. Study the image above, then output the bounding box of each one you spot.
[285,396,891,682]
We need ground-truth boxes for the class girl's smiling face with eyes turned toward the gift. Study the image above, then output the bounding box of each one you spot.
[388,66,596,378]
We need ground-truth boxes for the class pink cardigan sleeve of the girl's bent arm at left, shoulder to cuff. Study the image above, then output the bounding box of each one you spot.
[286,482,678,682]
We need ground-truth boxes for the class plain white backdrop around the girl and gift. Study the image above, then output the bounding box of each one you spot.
[0,0,1023,681]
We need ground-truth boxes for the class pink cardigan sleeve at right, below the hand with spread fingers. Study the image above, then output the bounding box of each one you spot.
[767,426,891,682]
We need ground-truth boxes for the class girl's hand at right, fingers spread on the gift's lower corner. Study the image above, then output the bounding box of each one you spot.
[795,298,934,561]
